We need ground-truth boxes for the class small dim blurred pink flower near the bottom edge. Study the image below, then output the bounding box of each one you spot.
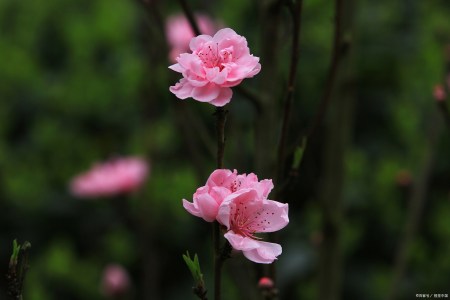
[101,264,130,298]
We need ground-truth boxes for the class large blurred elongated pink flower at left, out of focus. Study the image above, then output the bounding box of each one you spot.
[70,157,148,198]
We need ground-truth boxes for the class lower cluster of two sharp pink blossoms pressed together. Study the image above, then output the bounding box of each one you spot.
[183,169,289,264]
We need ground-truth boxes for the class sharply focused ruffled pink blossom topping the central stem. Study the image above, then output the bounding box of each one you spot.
[169,28,261,106]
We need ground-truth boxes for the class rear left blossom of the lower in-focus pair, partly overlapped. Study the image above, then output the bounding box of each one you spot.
[183,169,273,222]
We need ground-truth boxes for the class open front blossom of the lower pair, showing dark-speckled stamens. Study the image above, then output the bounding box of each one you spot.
[217,189,289,264]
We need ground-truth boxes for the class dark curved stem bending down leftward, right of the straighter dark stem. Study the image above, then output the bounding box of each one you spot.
[307,0,344,138]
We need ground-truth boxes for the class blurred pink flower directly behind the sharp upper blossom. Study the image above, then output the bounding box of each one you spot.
[166,14,217,63]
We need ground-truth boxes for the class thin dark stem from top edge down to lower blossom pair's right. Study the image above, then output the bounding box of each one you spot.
[275,0,303,183]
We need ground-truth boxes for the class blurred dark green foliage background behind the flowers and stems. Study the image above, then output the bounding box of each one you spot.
[0,0,450,300]
